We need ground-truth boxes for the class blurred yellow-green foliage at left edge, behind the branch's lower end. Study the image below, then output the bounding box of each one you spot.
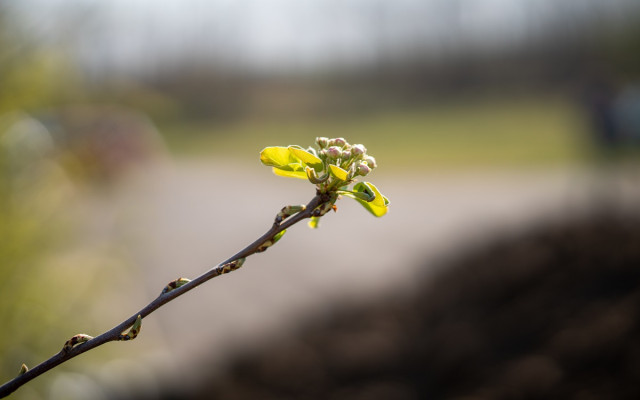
[0,112,127,399]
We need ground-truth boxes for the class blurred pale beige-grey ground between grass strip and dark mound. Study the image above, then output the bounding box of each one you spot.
[55,160,640,393]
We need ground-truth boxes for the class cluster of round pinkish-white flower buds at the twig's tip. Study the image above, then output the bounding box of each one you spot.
[310,137,377,179]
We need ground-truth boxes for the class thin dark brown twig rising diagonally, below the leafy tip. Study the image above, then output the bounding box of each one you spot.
[0,194,330,398]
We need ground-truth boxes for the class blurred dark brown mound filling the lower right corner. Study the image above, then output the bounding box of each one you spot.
[142,211,640,400]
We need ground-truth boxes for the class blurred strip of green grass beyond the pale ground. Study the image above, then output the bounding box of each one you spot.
[161,96,587,171]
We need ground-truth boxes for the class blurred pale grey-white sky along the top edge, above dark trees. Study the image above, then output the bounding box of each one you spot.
[6,0,640,76]
